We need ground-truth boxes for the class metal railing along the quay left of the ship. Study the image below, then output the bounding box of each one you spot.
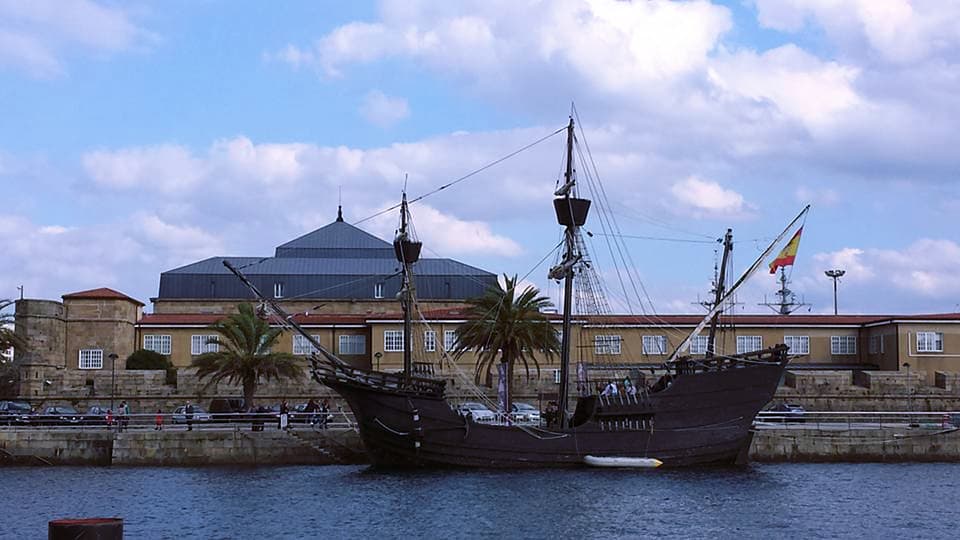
[0,410,356,432]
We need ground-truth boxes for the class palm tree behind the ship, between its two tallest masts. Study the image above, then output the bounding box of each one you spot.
[454,274,560,412]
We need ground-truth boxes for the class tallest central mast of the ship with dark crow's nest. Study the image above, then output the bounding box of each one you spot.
[549,117,590,427]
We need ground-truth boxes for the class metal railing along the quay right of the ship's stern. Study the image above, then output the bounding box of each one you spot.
[753,411,960,430]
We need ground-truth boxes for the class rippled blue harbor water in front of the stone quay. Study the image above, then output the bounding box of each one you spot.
[0,464,960,539]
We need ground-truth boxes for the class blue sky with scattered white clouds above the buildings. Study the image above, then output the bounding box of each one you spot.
[0,0,960,314]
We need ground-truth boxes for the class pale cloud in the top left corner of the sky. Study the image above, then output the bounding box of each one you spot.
[0,0,156,77]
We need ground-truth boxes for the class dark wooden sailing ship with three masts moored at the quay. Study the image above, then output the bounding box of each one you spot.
[224,119,806,468]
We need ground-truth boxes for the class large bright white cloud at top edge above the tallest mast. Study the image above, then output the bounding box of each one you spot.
[273,0,732,93]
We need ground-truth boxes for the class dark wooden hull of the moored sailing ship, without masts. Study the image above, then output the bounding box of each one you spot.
[318,346,787,468]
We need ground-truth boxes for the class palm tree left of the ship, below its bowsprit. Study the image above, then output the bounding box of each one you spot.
[193,304,303,408]
